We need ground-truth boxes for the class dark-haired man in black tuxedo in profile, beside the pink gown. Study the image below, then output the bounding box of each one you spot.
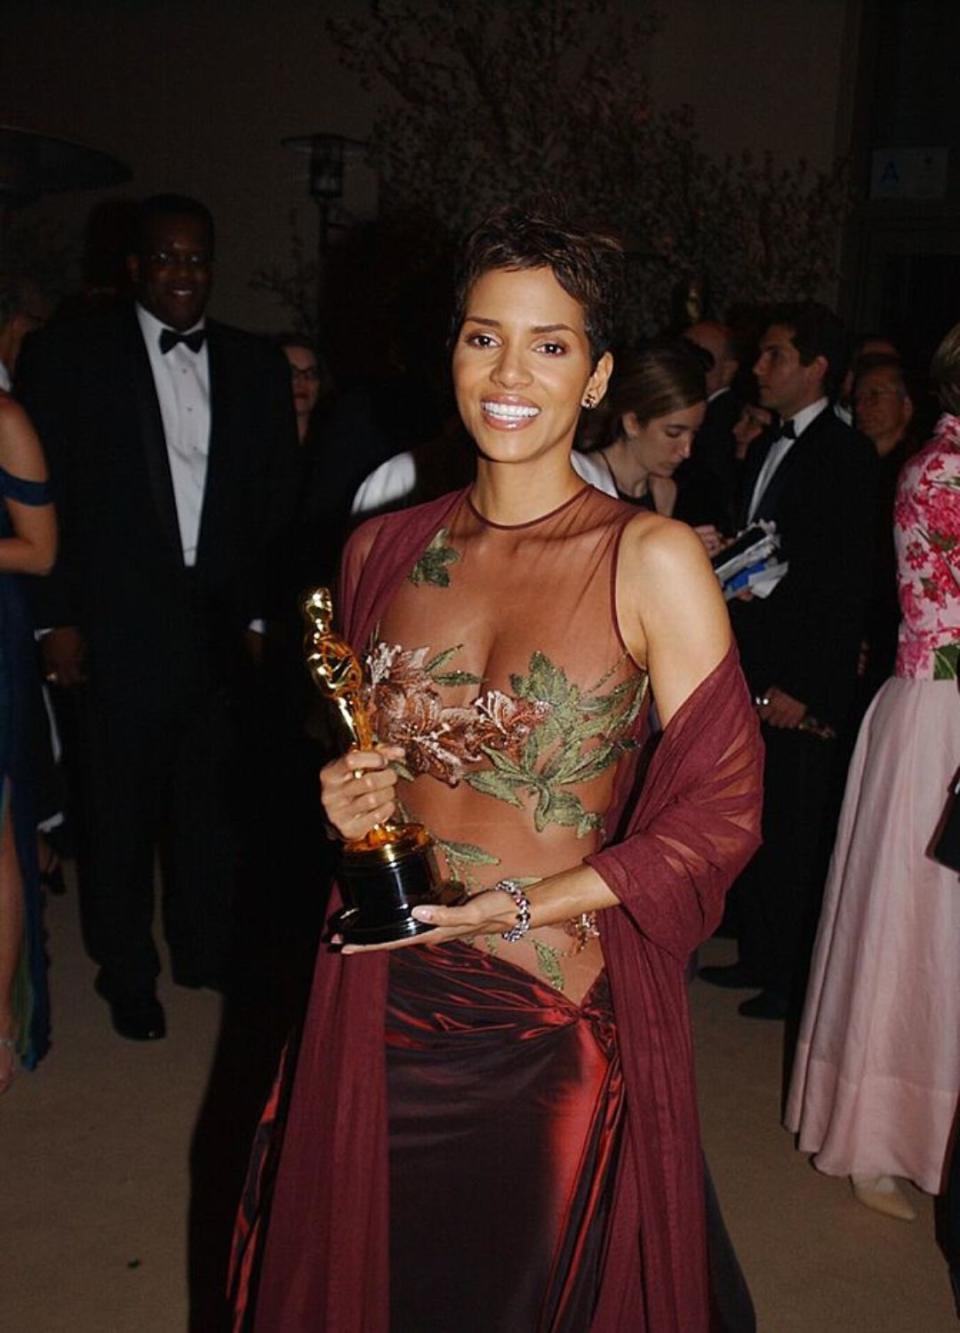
[701,303,877,1018]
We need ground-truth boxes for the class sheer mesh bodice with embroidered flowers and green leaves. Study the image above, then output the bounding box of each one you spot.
[368,487,647,1000]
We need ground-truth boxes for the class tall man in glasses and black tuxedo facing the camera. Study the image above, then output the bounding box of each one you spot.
[19,196,296,1040]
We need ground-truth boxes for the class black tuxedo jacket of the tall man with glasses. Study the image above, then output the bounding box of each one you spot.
[17,305,296,706]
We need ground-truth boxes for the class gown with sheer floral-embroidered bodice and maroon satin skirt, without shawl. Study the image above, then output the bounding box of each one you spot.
[368,487,647,1333]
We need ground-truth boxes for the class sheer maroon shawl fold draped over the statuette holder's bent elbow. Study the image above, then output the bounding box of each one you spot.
[587,648,763,960]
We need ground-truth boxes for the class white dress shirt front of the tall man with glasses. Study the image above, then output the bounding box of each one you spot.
[136,304,211,565]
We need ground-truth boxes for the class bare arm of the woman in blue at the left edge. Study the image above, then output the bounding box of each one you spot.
[0,396,57,575]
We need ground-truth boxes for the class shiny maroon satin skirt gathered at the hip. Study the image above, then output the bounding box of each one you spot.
[387,941,624,1333]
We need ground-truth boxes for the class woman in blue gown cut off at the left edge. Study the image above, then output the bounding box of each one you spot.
[0,392,56,1093]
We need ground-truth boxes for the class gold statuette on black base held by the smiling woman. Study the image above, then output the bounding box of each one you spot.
[301,588,463,944]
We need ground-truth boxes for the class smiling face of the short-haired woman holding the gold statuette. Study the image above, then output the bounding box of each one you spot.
[453,268,613,463]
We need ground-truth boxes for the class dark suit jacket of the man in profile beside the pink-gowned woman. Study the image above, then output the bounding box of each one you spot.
[729,407,877,728]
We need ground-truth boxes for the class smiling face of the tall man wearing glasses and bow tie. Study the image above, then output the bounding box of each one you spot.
[127,213,213,332]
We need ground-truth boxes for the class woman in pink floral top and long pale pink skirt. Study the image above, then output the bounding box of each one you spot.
[785,325,960,1218]
